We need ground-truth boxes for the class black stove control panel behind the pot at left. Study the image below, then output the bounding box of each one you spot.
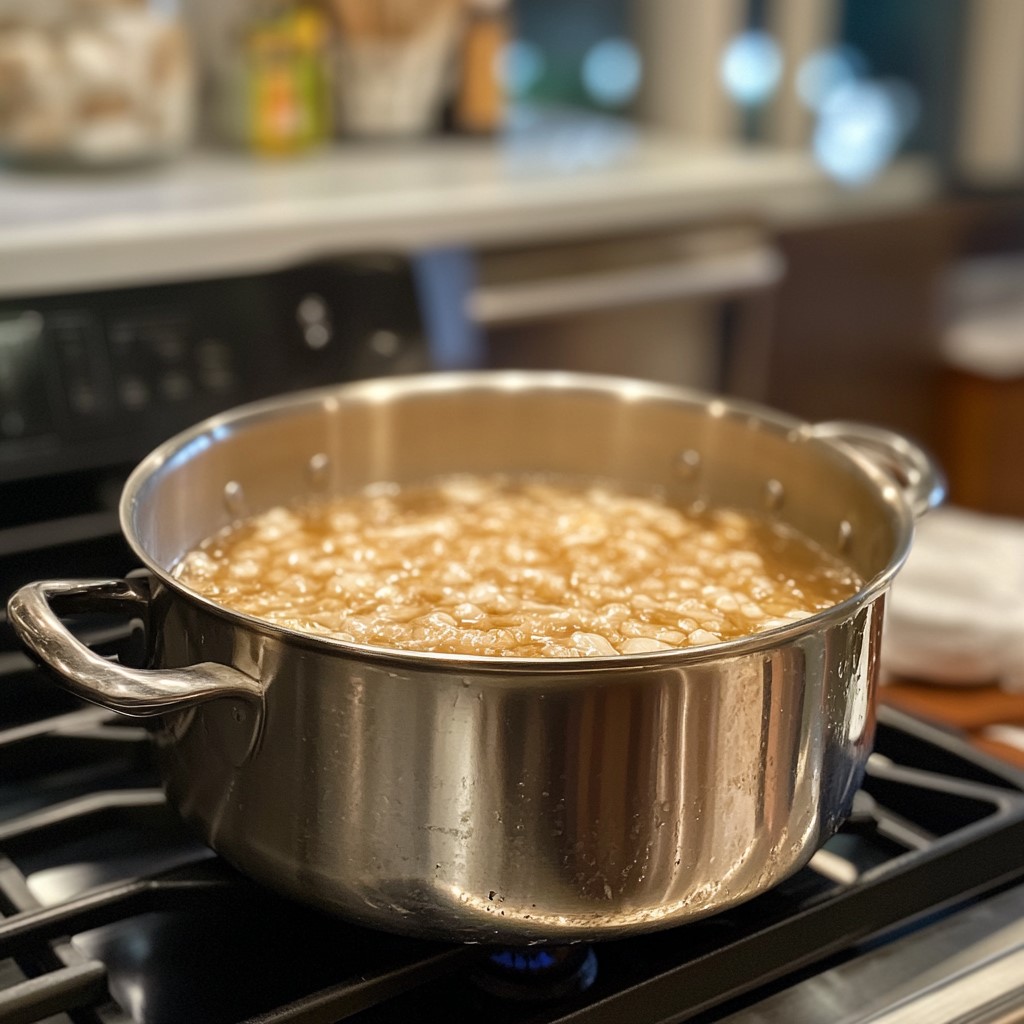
[0,256,430,481]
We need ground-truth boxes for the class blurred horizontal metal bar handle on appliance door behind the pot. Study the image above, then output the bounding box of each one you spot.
[467,245,784,327]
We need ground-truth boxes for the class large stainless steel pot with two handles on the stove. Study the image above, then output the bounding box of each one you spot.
[9,373,942,942]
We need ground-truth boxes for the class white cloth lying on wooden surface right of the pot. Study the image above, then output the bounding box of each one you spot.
[882,508,1024,691]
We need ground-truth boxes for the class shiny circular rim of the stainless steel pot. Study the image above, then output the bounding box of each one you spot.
[119,370,914,676]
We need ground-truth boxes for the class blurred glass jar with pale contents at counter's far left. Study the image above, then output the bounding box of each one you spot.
[0,0,196,167]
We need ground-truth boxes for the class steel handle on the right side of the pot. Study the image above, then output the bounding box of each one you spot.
[810,420,946,519]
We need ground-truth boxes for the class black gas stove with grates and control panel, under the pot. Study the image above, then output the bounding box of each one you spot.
[0,261,1024,1024]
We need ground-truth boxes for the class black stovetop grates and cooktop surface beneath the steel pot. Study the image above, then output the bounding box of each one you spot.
[0,622,1024,1024]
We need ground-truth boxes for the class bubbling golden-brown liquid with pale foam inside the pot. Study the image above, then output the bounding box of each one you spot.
[174,476,861,657]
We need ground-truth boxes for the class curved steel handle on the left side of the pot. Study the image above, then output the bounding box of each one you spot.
[7,579,263,718]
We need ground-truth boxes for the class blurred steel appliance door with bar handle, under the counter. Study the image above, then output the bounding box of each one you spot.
[423,223,783,398]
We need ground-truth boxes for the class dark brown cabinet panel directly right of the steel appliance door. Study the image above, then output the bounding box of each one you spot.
[767,203,956,444]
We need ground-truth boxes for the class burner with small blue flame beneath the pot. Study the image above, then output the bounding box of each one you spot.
[473,944,597,1002]
